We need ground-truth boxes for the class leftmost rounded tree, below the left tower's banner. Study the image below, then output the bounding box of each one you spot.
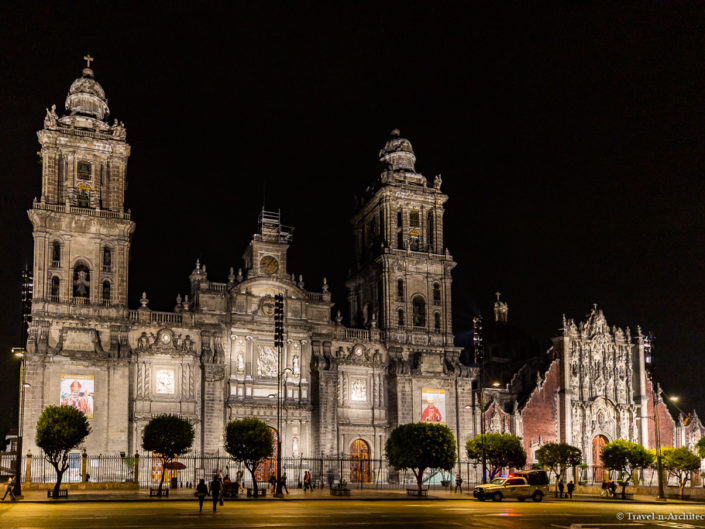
[34,406,91,498]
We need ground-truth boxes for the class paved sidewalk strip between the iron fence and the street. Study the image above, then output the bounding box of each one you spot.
[5,488,703,505]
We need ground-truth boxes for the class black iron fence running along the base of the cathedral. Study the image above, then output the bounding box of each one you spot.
[0,452,684,490]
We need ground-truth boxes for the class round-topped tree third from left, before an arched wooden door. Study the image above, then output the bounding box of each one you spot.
[225,418,274,496]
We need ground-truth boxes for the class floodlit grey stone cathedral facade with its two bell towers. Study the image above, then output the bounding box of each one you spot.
[24,60,475,458]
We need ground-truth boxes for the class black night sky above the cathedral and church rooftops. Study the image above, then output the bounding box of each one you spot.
[0,1,705,428]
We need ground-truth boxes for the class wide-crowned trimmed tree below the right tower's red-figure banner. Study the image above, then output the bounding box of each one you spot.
[384,422,457,495]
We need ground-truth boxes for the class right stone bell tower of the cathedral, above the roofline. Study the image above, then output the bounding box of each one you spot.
[346,129,455,338]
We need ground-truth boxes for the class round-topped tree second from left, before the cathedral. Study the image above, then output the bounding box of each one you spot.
[142,414,194,496]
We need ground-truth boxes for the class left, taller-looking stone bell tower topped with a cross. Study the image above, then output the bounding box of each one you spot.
[28,55,135,313]
